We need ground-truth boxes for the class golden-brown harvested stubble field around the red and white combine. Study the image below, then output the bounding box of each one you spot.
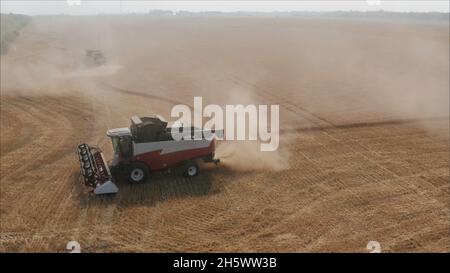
[0,16,450,252]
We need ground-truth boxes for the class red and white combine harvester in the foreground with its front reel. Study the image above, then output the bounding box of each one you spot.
[78,116,219,194]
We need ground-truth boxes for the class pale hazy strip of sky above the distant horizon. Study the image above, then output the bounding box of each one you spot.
[1,0,449,15]
